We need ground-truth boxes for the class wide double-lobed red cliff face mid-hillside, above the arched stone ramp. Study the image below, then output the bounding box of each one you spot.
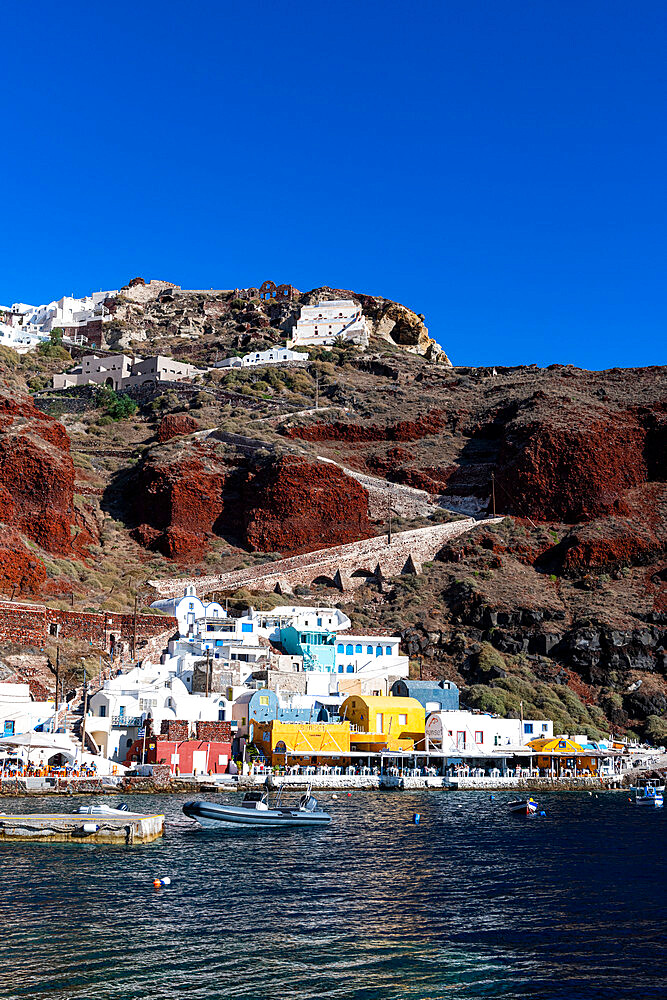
[131,440,374,561]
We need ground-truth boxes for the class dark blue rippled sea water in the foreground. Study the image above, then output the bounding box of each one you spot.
[0,792,667,1000]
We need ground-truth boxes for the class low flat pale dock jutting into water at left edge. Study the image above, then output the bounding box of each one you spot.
[0,812,164,844]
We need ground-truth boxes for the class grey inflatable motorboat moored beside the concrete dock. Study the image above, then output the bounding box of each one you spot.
[183,788,331,829]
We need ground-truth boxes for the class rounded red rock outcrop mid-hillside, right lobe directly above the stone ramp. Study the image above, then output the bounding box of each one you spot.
[242,455,373,554]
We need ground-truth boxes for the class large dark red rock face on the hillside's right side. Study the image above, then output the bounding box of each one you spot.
[496,407,647,523]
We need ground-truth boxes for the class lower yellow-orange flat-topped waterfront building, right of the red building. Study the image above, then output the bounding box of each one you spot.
[253,719,350,764]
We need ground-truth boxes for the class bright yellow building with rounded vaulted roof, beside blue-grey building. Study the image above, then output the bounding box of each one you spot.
[340,694,426,753]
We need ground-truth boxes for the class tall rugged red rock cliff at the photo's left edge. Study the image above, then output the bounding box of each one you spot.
[0,396,74,555]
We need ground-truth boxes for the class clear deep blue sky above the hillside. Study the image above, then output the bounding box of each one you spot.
[0,0,667,368]
